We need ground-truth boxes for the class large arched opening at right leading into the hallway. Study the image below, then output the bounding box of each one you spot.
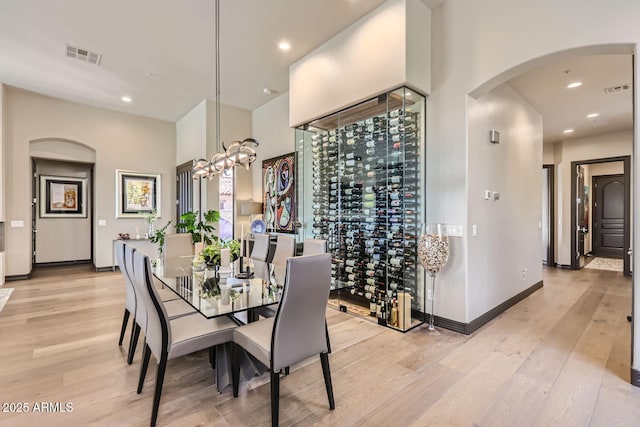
[467,44,639,385]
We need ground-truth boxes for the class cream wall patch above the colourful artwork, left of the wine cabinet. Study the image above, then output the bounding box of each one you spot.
[251,92,296,202]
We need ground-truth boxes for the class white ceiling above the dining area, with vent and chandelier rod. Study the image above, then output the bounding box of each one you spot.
[0,0,416,121]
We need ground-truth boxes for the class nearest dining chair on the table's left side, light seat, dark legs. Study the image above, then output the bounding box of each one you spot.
[134,252,237,426]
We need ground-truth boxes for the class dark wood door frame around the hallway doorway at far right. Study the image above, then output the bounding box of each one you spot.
[570,156,631,276]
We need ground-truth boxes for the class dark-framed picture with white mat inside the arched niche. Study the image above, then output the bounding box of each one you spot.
[40,175,87,218]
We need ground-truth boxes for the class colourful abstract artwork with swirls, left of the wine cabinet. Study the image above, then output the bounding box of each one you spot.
[262,153,296,233]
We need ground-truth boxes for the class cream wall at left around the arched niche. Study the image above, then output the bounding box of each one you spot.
[4,87,176,275]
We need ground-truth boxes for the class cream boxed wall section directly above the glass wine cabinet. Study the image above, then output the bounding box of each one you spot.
[289,0,431,126]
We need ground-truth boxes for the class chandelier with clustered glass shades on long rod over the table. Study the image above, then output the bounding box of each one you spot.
[191,0,259,179]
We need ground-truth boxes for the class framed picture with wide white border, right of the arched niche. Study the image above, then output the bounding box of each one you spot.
[116,169,161,218]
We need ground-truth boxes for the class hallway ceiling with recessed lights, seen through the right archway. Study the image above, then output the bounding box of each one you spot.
[509,55,633,143]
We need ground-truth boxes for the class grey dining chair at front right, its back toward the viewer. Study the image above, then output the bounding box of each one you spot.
[232,254,335,426]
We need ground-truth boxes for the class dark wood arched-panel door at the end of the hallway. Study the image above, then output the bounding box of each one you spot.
[593,175,625,258]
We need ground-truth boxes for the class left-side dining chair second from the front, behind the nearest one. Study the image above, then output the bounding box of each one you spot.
[124,245,196,365]
